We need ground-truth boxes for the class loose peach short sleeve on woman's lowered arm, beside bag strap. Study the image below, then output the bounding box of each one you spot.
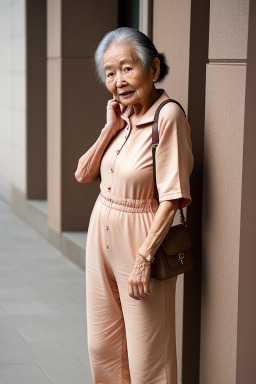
[156,103,194,208]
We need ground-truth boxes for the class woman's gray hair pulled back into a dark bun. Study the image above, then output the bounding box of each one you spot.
[94,27,169,83]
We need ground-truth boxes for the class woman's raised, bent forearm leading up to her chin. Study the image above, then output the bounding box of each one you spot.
[75,124,116,183]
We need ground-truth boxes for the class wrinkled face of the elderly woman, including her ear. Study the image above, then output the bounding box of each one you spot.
[103,42,159,106]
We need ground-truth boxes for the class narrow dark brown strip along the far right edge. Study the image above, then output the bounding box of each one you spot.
[236,0,256,384]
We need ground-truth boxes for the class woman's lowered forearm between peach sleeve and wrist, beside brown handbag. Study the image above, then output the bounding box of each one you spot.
[139,199,180,260]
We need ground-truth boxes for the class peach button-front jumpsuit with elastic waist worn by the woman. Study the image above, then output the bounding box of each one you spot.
[85,89,194,384]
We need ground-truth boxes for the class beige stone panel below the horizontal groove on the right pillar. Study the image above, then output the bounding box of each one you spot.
[200,64,246,384]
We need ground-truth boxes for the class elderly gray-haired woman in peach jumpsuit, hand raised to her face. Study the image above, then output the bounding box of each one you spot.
[75,27,194,384]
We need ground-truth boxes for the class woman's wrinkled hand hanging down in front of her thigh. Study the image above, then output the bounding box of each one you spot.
[128,254,152,300]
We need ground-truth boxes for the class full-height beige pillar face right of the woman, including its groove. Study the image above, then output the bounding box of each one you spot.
[200,0,249,384]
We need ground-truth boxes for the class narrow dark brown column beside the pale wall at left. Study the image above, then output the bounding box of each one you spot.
[26,0,47,199]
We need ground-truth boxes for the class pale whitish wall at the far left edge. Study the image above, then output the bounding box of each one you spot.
[0,0,26,193]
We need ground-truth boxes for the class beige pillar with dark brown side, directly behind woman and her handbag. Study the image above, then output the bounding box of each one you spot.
[153,0,209,384]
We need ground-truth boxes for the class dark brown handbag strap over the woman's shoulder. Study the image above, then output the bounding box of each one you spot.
[152,99,187,225]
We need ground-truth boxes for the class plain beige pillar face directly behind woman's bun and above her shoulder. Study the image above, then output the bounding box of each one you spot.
[153,0,190,111]
